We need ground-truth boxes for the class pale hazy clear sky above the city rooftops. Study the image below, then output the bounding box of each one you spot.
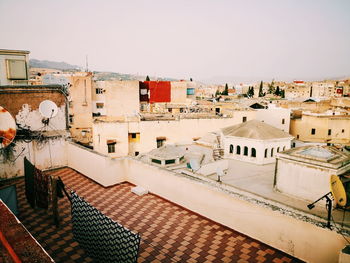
[0,0,350,82]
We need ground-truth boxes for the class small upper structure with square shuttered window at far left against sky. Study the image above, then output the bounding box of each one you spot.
[0,49,29,85]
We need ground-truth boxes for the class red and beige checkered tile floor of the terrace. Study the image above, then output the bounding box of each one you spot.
[17,168,301,263]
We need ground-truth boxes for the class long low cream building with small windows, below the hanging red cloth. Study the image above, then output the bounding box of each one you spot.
[93,114,253,157]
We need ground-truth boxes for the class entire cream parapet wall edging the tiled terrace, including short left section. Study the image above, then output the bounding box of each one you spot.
[63,143,346,263]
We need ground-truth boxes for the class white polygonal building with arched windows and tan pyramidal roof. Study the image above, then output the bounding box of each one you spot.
[221,120,293,164]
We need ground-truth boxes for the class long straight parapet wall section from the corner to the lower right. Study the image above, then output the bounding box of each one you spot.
[126,159,346,263]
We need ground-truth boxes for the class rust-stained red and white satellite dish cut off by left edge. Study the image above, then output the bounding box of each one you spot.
[0,106,16,149]
